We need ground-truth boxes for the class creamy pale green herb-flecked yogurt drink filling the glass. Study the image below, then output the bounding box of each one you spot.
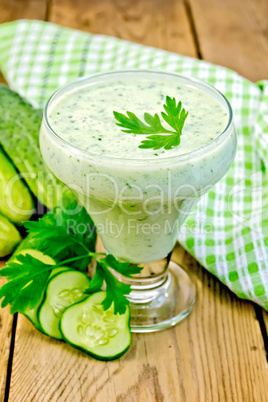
[40,72,236,264]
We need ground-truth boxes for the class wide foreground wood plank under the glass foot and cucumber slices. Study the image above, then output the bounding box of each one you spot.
[10,243,268,402]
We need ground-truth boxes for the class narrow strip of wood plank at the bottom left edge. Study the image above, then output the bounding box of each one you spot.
[0,261,13,401]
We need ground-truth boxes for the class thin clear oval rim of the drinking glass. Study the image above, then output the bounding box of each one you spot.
[43,69,233,165]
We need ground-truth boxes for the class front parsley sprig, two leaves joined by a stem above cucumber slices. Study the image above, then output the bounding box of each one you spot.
[0,250,143,314]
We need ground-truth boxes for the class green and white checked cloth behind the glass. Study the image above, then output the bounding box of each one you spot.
[0,20,268,309]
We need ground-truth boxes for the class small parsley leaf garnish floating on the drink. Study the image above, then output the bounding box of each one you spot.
[113,96,188,150]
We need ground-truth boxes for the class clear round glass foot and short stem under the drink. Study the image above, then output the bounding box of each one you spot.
[128,261,196,332]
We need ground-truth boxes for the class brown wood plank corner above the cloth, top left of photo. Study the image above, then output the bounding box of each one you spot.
[0,0,47,23]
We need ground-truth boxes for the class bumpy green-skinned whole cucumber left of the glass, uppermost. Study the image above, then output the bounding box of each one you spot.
[0,85,75,208]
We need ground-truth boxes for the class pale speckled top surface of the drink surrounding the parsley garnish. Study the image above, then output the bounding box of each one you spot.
[48,79,228,160]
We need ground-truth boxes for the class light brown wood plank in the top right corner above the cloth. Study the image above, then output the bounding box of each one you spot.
[187,0,268,81]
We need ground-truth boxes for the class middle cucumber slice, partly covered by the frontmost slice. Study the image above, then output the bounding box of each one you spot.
[38,270,90,339]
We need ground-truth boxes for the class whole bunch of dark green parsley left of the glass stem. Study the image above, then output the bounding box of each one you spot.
[0,203,142,314]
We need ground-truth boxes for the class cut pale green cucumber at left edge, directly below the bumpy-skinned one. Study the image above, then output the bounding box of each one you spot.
[0,149,34,225]
